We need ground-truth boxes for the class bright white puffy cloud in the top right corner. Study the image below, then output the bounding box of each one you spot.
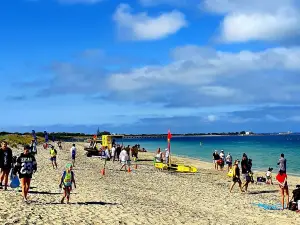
[202,0,300,42]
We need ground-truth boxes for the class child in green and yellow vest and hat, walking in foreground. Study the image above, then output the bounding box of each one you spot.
[59,163,76,204]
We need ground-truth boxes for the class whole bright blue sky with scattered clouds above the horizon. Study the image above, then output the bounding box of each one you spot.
[0,0,300,133]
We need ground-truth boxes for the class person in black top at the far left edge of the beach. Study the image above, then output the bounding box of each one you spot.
[0,141,13,191]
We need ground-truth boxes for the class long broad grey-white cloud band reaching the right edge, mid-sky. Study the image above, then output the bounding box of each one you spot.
[107,46,300,107]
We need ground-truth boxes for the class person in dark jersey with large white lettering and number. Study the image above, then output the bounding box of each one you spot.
[13,145,37,202]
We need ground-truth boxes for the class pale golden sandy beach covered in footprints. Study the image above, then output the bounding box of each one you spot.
[0,143,300,225]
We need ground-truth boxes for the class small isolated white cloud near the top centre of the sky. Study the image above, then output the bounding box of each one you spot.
[113,4,187,40]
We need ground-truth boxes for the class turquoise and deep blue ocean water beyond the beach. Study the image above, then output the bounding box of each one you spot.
[124,135,300,175]
